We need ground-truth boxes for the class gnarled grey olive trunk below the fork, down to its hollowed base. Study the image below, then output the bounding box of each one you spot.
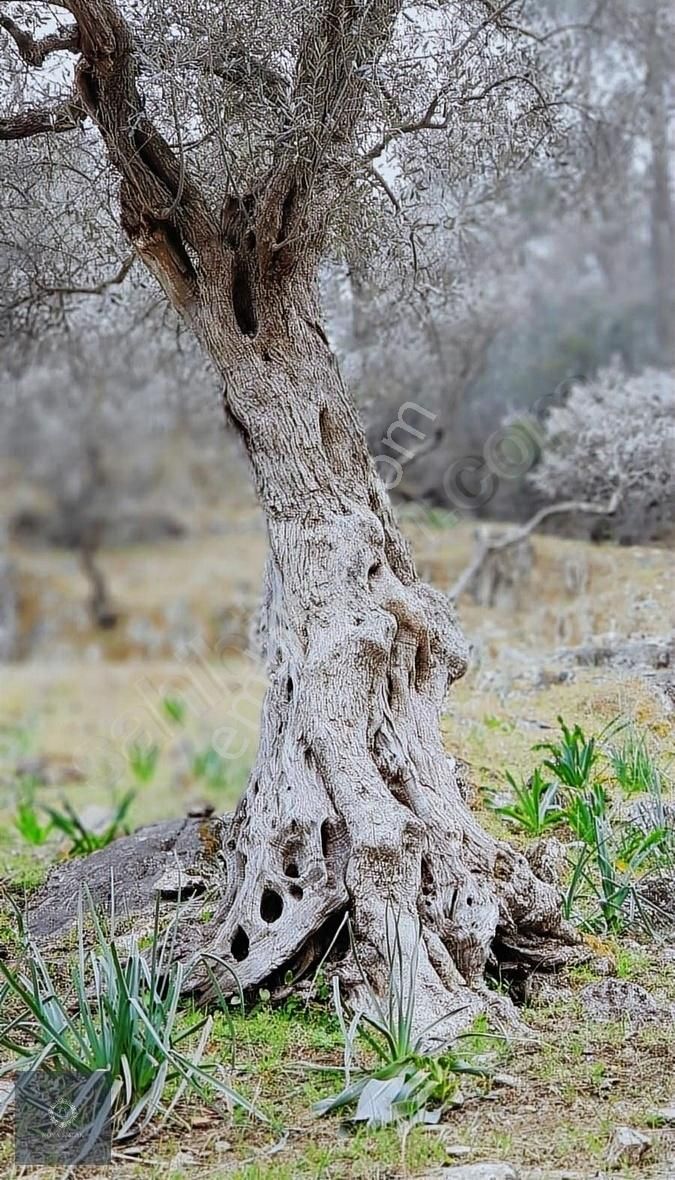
[187,273,574,1038]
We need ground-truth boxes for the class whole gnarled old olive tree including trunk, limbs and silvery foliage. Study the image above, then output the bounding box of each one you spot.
[0,0,575,1036]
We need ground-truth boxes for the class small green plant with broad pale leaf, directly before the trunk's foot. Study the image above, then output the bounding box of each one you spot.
[314,915,492,1127]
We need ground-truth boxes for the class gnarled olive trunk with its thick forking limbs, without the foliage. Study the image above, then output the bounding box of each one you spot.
[0,0,575,1038]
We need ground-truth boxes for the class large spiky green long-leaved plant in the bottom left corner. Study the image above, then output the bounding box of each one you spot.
[0,894,262,1140]
